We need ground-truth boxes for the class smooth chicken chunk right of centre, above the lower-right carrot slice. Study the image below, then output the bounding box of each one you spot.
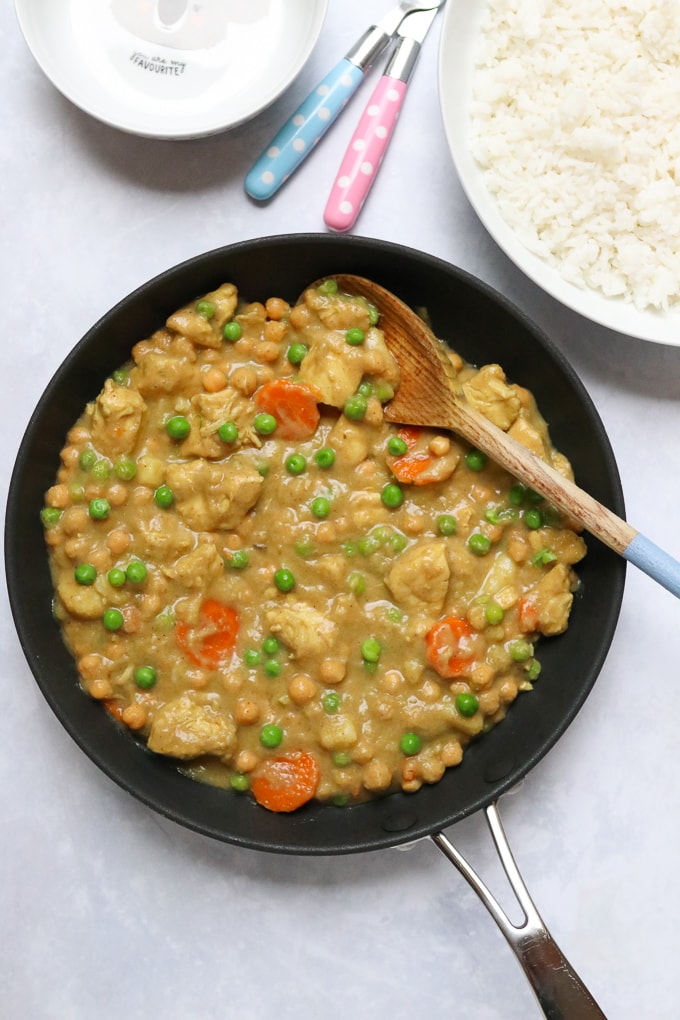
[385,541,451,618]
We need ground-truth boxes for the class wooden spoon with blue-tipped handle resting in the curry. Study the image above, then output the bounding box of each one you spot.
[326,273,680,598]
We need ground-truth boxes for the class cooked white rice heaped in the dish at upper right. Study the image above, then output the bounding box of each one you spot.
[471,0,680,309]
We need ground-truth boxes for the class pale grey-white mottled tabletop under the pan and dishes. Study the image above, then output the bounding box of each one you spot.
[0,0,680,1020]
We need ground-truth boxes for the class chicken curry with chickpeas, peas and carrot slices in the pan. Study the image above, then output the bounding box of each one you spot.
[43,281,585,811]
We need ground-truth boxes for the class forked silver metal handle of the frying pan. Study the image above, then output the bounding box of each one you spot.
[431,804,607,1020]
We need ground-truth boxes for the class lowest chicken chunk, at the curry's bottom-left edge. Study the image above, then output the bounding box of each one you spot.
[148,695,237,761]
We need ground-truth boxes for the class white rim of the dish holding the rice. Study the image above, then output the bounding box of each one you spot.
[438,0,680,347]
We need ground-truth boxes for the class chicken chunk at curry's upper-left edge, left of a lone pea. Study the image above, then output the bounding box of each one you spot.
[130,329,199,397]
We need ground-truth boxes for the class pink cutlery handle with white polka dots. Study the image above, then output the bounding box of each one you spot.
[323,74,407,231]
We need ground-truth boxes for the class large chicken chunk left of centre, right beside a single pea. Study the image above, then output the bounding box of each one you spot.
[166,453,263,531]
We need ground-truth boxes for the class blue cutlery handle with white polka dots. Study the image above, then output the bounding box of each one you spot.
[246,57,365,200]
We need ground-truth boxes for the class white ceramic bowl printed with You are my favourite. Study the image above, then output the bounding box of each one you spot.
[15,0,328,139]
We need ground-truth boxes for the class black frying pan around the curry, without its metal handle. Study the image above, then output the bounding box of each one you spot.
[5,235,625,1020]
